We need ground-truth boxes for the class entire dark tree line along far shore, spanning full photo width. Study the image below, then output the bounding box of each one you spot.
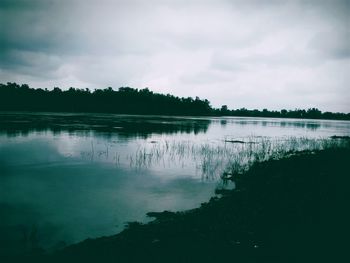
[0,82,350,120]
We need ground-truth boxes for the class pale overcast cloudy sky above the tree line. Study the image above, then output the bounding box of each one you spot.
[0,0,350,112]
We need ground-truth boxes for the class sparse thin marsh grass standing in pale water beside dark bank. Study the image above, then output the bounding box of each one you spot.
[124,136,349,180]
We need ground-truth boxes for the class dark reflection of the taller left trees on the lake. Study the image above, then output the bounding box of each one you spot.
[0,113,210,138]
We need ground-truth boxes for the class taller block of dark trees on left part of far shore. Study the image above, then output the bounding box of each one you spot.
[0,83,212,115]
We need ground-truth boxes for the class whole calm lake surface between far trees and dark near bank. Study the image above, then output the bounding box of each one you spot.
[0,113,350,253]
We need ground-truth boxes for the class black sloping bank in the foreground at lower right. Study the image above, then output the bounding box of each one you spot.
[5,147,350,262]
